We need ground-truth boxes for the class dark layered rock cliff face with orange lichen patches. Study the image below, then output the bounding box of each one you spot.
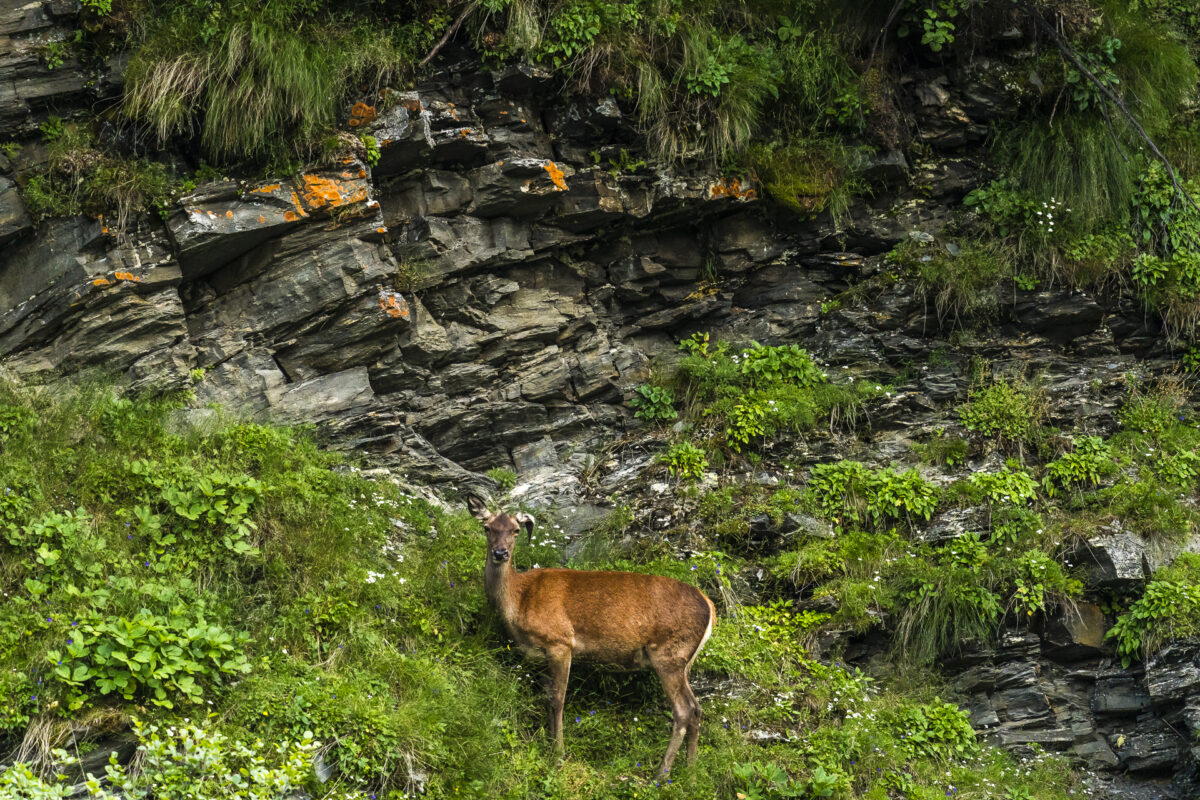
[0,1,1200,796]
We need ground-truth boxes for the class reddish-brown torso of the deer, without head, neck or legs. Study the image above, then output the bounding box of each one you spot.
[516,570,713,669]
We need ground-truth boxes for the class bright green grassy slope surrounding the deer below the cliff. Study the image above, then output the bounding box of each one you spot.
[0,381,1073,800]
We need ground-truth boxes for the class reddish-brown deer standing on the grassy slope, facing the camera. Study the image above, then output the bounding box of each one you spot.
[467,494,716,774]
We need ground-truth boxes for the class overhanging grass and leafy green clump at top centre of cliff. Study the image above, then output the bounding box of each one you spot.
[475,0,857,163]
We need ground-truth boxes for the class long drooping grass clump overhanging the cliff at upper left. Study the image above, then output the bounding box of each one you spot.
[122,4,440,162]
